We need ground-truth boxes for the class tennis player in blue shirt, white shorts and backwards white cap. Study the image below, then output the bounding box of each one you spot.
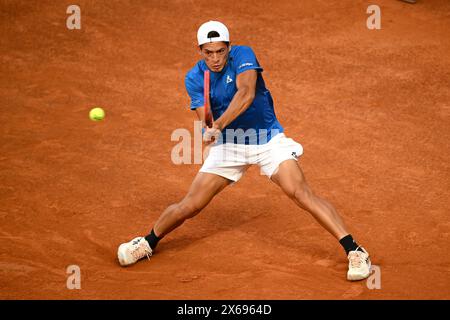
[118,21,370,280]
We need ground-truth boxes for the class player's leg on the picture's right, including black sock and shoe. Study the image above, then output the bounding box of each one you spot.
[271,160,370,280]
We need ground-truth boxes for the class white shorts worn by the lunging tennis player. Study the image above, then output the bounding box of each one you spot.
[200,133,303,182]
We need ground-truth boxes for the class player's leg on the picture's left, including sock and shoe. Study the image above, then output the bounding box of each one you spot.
[117,172,232,266]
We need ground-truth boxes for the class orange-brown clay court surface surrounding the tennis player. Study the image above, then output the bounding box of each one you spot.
[0,0,450,299]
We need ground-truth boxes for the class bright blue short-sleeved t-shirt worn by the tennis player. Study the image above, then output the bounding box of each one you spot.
[185,46,283,144]
